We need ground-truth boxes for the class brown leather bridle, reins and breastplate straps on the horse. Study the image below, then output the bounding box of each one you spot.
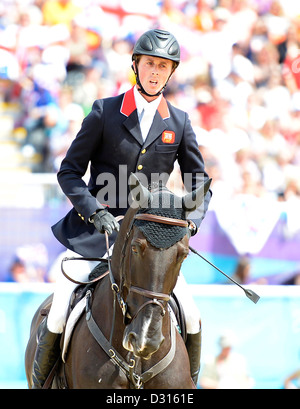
[62,213,188,389]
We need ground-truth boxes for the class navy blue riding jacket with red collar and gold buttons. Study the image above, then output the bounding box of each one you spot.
[52,88,211,257]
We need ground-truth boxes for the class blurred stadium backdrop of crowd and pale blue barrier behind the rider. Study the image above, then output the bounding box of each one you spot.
[0,0,300,389]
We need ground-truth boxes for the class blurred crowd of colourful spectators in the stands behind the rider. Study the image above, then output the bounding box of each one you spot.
[0,0,300,282]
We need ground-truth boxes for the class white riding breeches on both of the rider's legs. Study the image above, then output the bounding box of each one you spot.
[47,250,200,334]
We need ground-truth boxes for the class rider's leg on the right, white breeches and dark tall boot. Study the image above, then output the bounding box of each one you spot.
[174,273,201,385]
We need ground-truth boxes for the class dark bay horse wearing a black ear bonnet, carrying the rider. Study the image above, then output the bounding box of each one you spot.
[25,175,210,389]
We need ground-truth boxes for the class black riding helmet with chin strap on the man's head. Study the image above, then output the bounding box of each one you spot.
[132,29,180,97]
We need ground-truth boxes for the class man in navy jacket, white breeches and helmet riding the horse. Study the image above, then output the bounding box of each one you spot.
[33,29,211,388]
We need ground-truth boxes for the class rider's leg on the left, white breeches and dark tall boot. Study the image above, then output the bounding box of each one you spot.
[32,250,98,389]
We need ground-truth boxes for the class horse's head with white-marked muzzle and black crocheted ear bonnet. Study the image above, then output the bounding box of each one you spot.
[113,174,211,359]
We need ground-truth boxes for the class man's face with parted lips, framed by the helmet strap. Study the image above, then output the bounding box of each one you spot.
[134,55,173,101]
